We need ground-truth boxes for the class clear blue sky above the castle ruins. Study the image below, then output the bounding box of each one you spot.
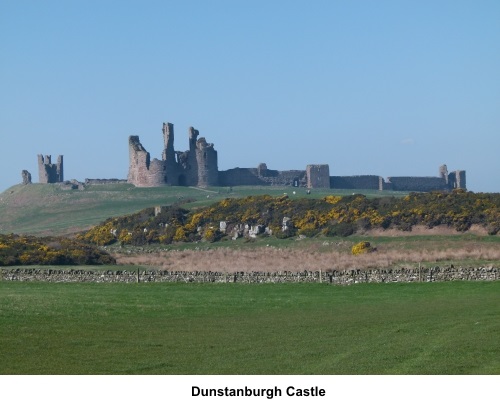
[0,0,500,192]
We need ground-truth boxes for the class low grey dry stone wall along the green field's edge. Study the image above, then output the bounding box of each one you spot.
[1,266,500,285]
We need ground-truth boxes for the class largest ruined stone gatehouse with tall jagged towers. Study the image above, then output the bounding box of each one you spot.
[128,123,219,187]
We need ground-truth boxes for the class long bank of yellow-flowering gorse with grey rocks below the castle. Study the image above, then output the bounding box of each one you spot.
[80,190,500,246]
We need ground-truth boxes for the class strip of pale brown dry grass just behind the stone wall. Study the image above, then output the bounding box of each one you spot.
[114,242,500,273]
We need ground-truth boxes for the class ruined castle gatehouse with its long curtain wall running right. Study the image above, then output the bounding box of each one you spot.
[128,123,466,192]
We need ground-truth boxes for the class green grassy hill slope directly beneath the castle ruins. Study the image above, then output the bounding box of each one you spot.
[0,184,406,235]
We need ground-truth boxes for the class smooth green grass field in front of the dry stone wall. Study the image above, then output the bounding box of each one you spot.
[0,282,500,375]
